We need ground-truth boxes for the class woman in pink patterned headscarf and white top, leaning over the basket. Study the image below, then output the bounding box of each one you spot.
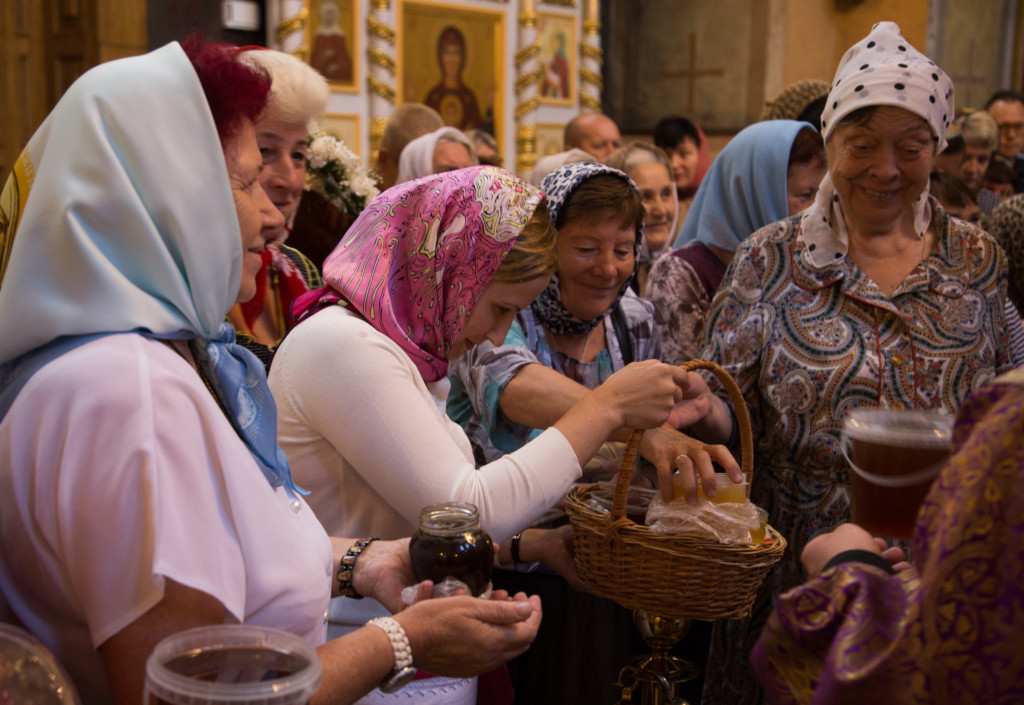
[270,167,682,702]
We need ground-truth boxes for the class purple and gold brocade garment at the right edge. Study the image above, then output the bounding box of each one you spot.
[753,370,1024,705]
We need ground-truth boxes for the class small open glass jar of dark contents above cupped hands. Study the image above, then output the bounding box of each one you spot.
[409,502,495,595]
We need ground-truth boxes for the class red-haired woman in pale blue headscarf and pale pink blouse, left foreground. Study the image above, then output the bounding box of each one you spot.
[0,35,541,705]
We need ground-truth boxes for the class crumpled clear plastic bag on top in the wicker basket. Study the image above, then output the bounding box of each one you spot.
[646,495,761,545]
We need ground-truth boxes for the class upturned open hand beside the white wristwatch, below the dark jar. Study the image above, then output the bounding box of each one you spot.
[395,592,542,678]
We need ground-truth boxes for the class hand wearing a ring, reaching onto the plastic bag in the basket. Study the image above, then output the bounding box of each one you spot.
[640,424,743,504]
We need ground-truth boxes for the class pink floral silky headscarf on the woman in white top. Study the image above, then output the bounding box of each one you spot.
[294,166,544,382]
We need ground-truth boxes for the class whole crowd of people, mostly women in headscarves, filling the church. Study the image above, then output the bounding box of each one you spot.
[0,23,1024,705]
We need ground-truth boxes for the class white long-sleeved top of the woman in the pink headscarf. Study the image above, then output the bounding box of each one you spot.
[270,306,581,541]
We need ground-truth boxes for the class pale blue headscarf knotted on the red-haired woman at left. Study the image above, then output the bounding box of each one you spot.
[0,43,303,489]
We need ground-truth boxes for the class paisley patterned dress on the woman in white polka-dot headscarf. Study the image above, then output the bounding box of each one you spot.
[703,202,1012,703]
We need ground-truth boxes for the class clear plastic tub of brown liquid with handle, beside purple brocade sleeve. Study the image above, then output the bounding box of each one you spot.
[842,409,953,539]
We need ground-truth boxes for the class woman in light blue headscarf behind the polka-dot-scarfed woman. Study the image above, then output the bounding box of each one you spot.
[644,120,825,365]
